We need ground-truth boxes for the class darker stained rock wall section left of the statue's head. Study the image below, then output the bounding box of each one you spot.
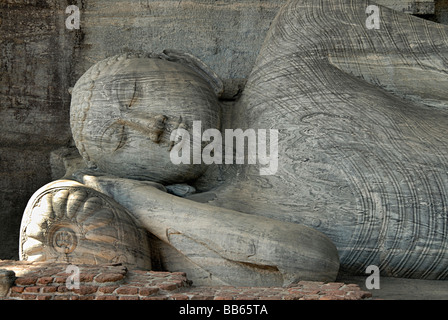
[0,0,77,259]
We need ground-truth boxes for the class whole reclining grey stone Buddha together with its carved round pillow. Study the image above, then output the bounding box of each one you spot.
[20,0,448,286]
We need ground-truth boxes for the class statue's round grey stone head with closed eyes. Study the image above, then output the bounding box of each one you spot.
[71,58,220,184]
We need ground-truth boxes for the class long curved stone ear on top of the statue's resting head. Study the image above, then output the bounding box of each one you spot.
[160,49,224,98]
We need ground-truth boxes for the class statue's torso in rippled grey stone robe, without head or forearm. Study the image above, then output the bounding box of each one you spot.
[205,0,448,279]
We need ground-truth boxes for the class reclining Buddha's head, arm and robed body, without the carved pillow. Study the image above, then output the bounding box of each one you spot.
[61,1,448,284]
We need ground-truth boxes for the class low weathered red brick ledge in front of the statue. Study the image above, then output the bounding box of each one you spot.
[0,260,371,300]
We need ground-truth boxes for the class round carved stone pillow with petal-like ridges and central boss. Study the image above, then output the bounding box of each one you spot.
[19,180,151,268]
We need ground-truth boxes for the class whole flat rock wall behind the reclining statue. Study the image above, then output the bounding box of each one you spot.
[0,0,448,259]
